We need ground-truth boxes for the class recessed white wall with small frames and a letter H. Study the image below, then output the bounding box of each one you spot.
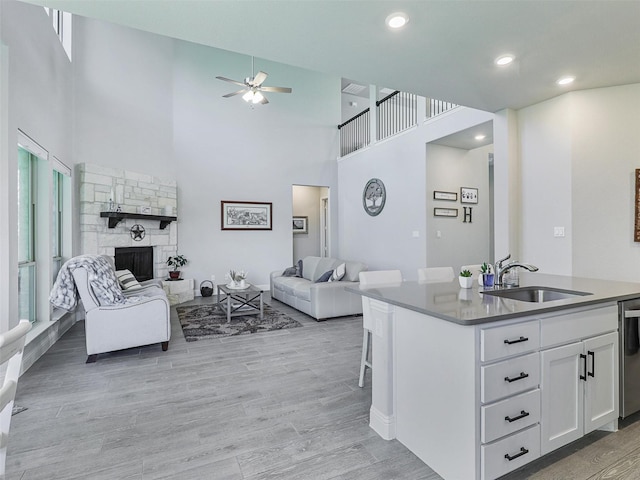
[425,144,493,271]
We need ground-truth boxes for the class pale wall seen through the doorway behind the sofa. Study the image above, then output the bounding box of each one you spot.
[291,185,323,265]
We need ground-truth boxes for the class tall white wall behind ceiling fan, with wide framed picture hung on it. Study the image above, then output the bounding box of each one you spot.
[74,19,340,286]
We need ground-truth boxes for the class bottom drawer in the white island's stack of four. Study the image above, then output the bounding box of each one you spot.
[480,425,540,480]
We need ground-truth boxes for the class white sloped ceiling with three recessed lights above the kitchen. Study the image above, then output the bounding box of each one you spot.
[20,0,640,112]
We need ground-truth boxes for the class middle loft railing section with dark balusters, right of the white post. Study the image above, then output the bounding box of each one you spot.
[376,90,418,140]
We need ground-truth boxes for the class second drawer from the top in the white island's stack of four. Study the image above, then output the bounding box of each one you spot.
[480,352,540,403]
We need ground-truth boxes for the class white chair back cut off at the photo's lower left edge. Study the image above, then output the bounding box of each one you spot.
[0,320,31,478]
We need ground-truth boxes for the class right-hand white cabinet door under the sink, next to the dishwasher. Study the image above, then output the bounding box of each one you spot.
[584,332,619,434]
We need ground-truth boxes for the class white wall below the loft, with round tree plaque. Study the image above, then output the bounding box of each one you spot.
[338,108,493,280]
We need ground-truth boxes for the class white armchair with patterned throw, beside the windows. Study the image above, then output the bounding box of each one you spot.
[73,260,171,363]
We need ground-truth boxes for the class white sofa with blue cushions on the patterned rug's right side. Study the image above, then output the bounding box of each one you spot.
[270,256,367,320]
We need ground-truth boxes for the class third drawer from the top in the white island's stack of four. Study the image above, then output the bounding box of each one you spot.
[481,389,540,443]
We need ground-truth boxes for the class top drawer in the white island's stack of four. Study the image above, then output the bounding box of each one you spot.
[480,320,540,362]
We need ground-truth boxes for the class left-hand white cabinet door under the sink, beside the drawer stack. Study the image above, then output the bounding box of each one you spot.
[540,342,585,455]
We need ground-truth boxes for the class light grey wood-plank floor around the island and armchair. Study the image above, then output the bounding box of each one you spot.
[5,297,640,480]
